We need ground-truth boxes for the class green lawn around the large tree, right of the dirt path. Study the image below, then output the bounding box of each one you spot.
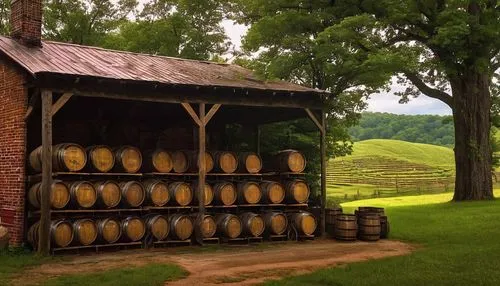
[266,189,500,285]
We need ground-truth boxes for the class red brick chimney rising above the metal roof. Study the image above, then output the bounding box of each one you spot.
[10,0,43,46]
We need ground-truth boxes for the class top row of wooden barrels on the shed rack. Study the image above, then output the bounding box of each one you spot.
[29,143,306,174]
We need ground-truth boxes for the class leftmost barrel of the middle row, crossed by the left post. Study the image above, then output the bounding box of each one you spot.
[28,180,70,209]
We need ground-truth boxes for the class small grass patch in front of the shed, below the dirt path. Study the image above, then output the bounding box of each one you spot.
[42,264,187,286]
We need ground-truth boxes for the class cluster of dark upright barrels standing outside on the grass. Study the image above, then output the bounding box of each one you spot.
[326,207,390,241]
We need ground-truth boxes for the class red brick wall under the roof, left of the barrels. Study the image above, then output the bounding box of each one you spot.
[0,55,27,245]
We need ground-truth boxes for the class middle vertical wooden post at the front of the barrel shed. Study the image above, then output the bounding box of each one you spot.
[196,103,207,245]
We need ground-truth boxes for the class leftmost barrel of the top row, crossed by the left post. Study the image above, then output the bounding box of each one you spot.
[29,143,87,172]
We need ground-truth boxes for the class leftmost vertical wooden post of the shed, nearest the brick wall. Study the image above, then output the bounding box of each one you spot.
[38,90,52,255]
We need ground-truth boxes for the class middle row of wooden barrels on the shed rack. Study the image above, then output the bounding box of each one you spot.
[28,179,310,210]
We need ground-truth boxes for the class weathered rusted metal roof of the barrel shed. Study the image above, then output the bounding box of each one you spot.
[0,36,323,92]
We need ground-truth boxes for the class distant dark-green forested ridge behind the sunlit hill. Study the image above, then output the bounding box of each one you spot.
[349,112,455,147]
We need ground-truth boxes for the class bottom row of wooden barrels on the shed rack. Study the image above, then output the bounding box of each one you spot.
[28,212,317,248]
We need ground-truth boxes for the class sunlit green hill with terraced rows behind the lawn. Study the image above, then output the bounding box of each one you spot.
[327,139,455,202]
